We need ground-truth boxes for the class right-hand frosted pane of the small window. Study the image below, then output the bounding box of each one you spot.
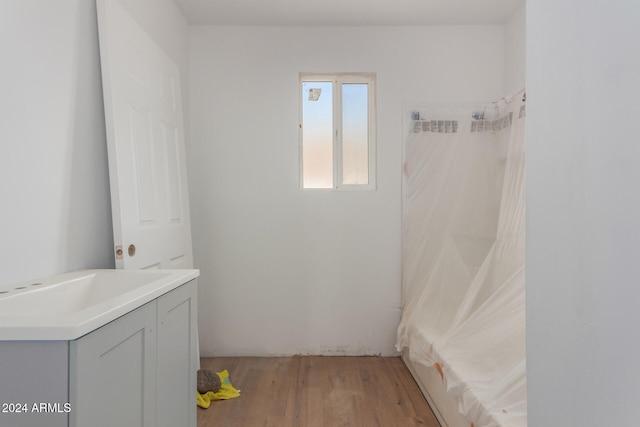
[342,83,369,185]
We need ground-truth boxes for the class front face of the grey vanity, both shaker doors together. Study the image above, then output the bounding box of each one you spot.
[69,281,197,427]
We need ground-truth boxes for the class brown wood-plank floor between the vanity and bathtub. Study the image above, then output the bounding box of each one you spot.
[198,356,439,427]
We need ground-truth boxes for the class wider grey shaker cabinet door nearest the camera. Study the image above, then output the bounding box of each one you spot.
[69,301,156,427]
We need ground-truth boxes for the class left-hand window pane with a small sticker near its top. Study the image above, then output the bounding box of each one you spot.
[302,82,333,188]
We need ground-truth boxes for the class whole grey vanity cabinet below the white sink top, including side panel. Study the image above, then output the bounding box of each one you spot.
[0,279,198,427]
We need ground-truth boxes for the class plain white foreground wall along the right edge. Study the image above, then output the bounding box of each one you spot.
[527,0,640,427]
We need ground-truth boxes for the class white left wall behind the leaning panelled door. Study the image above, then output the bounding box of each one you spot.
[0,0,188,283]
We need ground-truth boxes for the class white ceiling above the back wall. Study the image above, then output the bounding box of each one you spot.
[174,0,525,26]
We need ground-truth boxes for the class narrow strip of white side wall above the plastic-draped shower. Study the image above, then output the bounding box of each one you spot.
[504,4,527,95]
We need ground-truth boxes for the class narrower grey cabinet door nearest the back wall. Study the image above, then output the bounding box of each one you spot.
[158,280,198,427]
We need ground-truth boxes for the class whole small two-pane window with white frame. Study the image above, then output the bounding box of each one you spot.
[300,74,376,189]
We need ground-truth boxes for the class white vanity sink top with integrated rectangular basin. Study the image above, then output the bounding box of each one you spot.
[0,270,200,341]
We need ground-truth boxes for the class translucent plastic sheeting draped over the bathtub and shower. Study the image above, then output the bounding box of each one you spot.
[397,93,526,427]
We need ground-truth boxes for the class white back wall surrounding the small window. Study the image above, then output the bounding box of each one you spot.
[190,26,504,355]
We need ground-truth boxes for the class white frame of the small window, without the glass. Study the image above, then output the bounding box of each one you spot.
[298,73,377,191]
